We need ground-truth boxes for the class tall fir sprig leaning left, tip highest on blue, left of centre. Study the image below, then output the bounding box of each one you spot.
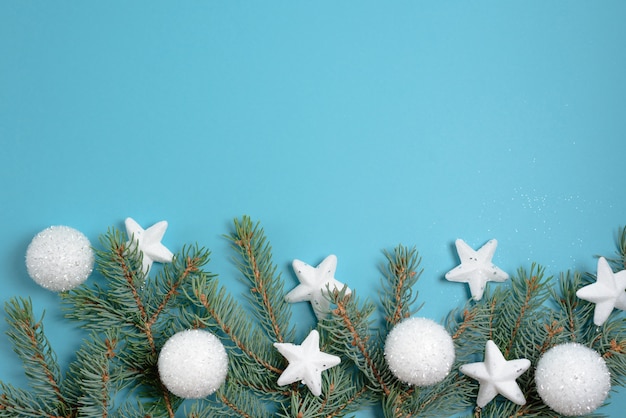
[228,216,294,343]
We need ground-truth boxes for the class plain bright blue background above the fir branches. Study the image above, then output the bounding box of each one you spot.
[0,1,626,416]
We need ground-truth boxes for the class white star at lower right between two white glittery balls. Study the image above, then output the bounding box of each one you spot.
[459,340,530,408]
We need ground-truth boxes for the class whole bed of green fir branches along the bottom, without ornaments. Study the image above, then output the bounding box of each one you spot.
[0,216,626,418]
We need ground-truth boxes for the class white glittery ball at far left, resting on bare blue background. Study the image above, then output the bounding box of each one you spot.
[26,226,94,292]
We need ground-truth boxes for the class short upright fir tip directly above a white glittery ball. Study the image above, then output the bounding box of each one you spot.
[381,245,423,331]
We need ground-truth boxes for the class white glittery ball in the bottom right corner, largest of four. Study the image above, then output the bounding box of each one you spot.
[535,343,611,416]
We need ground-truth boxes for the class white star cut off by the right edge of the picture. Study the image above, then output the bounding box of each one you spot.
[576,257,626,326]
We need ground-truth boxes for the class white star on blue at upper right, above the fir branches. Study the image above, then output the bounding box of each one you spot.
[445,239,509,300]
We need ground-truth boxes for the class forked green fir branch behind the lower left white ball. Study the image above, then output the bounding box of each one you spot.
[64,229,209,417]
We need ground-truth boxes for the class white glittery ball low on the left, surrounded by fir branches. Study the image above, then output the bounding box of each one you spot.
[158,329,228,399]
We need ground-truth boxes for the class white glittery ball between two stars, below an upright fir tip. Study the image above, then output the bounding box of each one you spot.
[385,318,455,386]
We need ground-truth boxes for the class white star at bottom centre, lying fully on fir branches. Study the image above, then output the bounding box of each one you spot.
[274,330,341,396]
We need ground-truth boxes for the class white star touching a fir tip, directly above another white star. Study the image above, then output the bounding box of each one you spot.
[285,255,351,319]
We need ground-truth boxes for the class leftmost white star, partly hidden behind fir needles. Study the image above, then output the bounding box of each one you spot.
[126,218,174,274]
